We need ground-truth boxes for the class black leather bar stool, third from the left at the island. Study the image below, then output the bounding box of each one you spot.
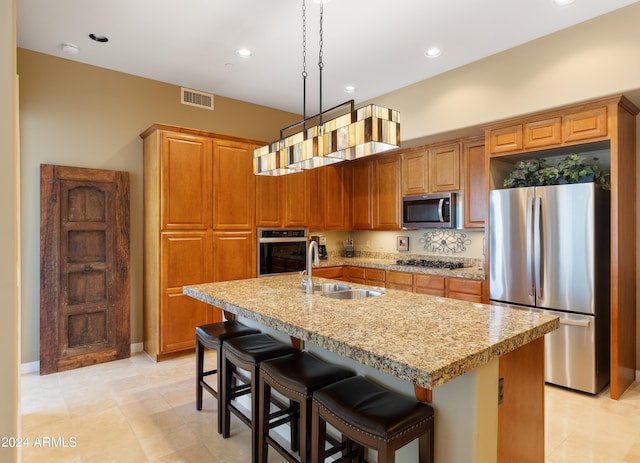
[258,352,355,463]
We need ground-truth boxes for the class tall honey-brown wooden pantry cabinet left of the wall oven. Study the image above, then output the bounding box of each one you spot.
[140,124,259,360]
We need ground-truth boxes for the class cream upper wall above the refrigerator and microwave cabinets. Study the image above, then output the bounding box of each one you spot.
[374,3,640,146]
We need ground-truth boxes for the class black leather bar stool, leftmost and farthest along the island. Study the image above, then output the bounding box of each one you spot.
[196,320,260,434]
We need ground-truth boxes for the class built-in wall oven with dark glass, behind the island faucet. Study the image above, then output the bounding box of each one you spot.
[257,228,308,277]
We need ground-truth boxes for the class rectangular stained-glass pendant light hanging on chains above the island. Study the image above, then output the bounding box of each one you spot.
[254,0,400,175]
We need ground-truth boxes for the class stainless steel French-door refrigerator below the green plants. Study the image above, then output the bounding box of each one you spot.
[489,183,610,394]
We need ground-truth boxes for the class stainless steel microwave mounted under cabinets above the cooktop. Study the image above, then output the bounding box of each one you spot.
[402,193,456,228]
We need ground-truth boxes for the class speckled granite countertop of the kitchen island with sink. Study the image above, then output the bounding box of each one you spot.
[183,275,559,389]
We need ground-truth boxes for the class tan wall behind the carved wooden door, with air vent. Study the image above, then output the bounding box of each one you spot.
[18,49,298,363]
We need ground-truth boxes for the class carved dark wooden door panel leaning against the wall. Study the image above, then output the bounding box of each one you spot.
[40,164,131,374]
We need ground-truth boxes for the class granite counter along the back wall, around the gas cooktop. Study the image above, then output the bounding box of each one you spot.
[319,256,485,281]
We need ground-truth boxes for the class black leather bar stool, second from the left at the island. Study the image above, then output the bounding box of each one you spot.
[219,333,299,463]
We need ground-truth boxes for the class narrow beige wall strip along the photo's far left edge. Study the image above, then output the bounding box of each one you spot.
[0,0,20,462]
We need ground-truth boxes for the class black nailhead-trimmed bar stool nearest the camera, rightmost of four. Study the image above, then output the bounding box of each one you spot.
[311,376,434,463]
